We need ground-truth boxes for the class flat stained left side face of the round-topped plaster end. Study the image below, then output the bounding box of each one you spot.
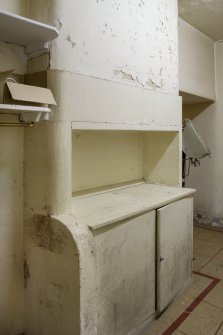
[25,215,80,335]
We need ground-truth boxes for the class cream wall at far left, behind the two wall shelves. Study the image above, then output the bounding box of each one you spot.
[0,0,26,335]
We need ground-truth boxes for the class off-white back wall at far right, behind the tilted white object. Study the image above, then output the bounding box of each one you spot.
[184,42,223,217]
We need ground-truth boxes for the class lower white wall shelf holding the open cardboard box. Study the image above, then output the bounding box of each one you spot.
[0,104,51,122]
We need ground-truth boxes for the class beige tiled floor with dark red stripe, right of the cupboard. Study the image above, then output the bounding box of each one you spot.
[144,227,223,335]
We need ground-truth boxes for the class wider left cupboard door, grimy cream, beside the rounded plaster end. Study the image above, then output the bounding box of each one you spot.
[94,211,156,335]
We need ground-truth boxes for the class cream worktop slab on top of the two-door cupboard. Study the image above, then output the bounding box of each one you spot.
[72,183,195,230]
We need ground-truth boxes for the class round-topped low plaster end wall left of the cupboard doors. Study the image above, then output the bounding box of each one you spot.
[24,215,97,335]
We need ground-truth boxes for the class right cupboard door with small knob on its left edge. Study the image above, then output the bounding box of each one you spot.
[157,197,193,312]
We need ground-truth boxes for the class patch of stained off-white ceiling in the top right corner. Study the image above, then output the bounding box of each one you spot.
[178,0,223,40]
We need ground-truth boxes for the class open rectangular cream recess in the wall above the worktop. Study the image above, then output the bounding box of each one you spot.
[72,130,180,197]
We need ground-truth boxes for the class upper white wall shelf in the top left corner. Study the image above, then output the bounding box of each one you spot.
[0,10,58,47]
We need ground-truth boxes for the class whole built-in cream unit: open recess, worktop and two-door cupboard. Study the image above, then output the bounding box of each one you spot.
[72,125,194,335]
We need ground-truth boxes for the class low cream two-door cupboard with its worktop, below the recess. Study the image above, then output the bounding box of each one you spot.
[73,183,193,335]
